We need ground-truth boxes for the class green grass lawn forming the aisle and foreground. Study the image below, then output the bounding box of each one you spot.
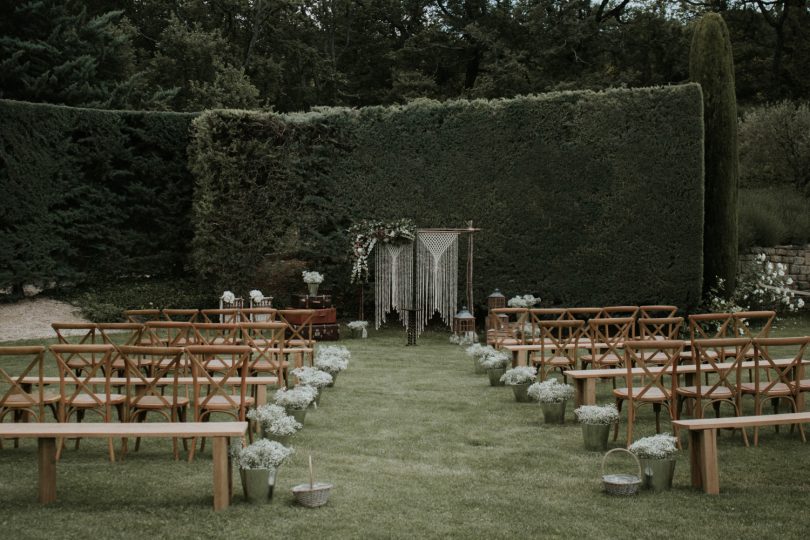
[0,321,810,538]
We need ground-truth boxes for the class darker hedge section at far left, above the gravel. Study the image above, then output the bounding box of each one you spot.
[0,100,194,287]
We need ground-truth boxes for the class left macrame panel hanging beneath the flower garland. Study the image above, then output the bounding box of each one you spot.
[374,242,413,329]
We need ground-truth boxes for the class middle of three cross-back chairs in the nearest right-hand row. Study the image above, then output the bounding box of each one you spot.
[676,338,753,446]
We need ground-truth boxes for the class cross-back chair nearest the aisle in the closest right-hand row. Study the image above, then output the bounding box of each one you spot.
[613,340,684,446]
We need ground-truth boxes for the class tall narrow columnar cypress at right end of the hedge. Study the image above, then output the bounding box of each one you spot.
[689,13,739,296]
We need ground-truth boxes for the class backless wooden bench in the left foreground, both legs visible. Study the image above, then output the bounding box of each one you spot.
[0,422,248,510]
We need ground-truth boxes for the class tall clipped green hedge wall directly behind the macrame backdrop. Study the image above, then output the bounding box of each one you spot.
[189,84,703,307]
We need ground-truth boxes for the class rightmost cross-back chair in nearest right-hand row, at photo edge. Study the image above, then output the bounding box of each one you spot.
[740,336,810,446]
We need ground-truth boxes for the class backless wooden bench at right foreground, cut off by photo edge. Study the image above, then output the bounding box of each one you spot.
[672,412,810,495]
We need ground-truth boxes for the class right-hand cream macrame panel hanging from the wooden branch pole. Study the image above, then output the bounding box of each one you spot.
[416,231,458,336]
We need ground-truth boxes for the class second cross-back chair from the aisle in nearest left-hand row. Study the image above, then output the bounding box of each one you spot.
[119,345,189,459]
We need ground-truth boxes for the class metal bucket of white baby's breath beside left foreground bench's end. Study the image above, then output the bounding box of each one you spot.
[233,439,293,504]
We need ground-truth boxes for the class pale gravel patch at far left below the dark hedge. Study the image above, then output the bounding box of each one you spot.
[0,298,88,341]
